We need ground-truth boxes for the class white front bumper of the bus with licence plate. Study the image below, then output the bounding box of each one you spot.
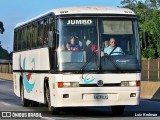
[51,87,140,107]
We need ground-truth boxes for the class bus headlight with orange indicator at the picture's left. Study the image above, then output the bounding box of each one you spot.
[58,82,79,88]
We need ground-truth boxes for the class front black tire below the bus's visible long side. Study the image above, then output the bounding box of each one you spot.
[45,83,59,115]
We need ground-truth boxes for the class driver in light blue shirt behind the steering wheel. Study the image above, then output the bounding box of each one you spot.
[104,38,124,55]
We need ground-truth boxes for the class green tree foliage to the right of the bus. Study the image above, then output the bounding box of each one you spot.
[121,0,160,59]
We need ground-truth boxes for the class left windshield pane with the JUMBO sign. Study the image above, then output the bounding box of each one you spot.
[57,18,98,70]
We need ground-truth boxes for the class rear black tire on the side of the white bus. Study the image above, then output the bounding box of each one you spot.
[20,83,31,107]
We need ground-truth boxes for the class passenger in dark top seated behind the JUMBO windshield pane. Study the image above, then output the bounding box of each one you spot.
[66,36,80,51]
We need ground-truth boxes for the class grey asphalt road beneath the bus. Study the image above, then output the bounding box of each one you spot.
[0,80,160,120]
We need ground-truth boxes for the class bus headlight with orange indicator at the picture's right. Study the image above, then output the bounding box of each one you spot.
[121,81,140,87]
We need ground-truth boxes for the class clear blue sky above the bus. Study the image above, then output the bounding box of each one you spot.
[0,0,122,52]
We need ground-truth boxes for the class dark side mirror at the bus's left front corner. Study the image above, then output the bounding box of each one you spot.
[48,31,55,49]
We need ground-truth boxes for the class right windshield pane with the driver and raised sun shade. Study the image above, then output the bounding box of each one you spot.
[99,19,140,71]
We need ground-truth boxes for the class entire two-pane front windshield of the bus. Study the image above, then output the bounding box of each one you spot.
[57,17,140,71]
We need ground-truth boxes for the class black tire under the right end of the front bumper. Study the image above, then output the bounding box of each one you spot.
[111,106,125,116]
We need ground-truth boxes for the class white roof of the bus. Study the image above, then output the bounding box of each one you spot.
[15,6,135,28]
